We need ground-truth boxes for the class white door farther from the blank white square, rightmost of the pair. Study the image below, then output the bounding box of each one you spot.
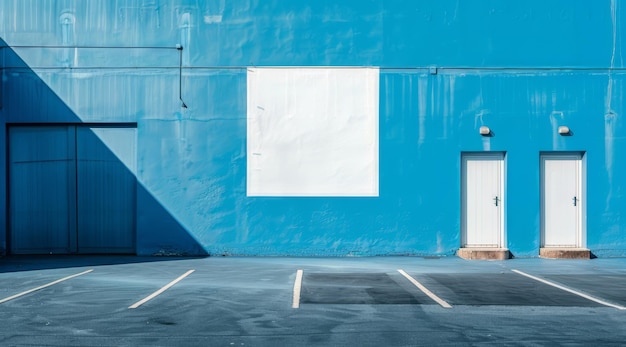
[541,154,584,247]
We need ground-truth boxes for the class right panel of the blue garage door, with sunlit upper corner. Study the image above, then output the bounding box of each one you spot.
[77,127,136,253]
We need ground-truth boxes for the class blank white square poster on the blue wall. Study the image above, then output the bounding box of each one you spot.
[247,67,379,196]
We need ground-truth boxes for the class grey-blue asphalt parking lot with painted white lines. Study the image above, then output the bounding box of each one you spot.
[0,256,626,346]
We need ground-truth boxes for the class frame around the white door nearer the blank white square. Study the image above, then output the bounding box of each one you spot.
[461,152,507,248]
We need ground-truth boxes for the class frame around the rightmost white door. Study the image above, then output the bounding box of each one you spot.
[539,151,587,248]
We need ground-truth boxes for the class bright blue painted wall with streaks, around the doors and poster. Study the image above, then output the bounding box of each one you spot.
[0,0,626,256]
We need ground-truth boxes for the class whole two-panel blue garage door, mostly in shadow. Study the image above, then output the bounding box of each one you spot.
[8,125,136,254]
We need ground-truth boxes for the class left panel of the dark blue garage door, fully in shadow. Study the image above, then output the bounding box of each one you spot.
[9,126,75,254]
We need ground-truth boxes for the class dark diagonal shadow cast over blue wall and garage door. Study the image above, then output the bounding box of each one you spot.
[0,39,206,262]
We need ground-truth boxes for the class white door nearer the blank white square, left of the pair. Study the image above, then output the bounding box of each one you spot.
[462,153,504,247]
